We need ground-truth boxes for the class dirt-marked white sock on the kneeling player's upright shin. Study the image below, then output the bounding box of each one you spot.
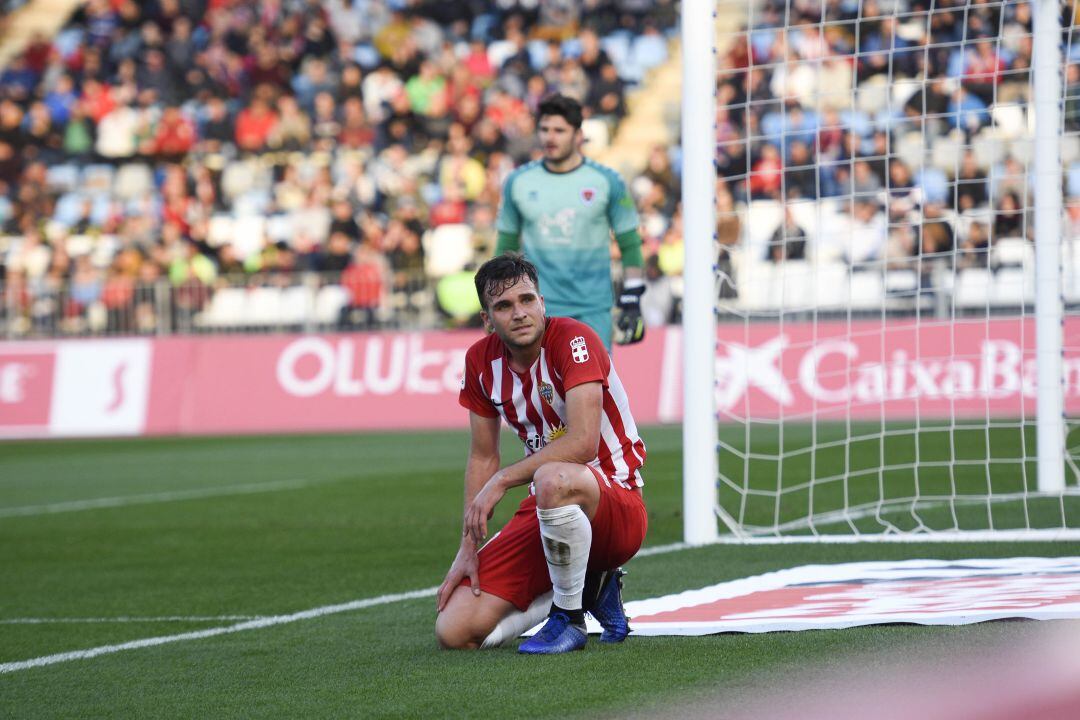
[537,505,593,610]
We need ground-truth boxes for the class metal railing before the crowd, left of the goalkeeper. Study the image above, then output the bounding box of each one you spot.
[0,272,447,340]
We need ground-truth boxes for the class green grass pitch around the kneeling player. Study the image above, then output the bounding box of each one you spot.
[0,427,1080,718]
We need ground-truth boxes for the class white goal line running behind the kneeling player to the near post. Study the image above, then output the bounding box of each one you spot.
[0,543,688,675]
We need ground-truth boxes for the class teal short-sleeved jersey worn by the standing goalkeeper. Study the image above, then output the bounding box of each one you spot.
[496,159,640,317]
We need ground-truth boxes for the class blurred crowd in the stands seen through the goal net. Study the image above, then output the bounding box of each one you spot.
[716,0,1080,283]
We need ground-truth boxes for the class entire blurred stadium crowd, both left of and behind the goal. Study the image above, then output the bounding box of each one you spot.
[0,0,1080,335]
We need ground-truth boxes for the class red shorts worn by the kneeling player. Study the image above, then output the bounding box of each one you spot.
[461,465,649,610]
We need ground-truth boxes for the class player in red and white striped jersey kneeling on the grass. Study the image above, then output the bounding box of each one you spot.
[435,254,647,654]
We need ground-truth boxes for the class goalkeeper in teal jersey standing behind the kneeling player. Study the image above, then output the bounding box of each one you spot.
[495,95,645,352]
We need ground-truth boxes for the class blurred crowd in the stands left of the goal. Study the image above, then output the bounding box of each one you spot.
[0,0,675,332]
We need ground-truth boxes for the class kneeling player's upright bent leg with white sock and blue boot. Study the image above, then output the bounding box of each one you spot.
[519,463,600,654]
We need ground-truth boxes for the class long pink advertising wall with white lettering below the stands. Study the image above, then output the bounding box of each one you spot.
[0,318,1080,438]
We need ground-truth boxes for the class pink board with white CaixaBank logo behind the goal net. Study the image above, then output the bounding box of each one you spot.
[716,322,1080,415]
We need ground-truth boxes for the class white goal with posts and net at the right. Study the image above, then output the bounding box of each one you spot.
[683,0,1080,542]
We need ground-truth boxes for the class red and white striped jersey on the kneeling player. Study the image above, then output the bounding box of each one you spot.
[458,317,645,488]
